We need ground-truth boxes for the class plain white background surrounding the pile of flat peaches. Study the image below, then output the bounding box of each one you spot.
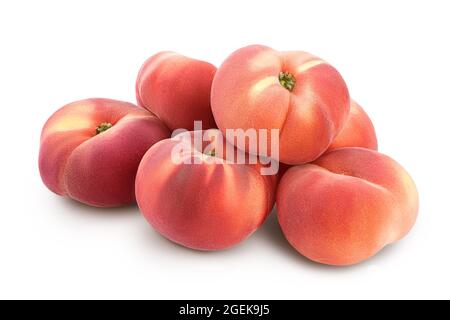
[0,0,450,299]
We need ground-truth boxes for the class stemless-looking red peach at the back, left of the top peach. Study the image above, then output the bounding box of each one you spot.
[136,52,217,131]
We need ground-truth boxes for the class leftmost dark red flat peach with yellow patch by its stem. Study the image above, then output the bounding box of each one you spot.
[39,99,170,207]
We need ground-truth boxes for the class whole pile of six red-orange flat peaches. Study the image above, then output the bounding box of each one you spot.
[39,45,418,265]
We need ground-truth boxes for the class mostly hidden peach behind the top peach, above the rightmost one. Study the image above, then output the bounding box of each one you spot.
[327,100,378,151]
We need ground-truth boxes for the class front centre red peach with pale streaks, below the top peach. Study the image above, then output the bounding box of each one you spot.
[136,130,277,250]
